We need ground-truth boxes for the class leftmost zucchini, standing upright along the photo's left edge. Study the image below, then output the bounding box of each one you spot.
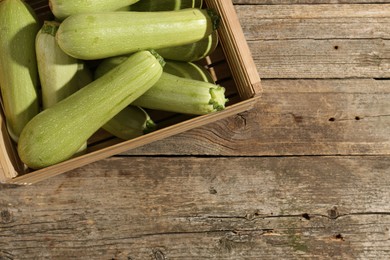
[0,0,40,142]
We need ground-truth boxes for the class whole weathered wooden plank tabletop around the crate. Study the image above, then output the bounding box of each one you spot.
[0,0,390,260]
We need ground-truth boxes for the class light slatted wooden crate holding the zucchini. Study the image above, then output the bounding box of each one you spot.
[0,0,262,185]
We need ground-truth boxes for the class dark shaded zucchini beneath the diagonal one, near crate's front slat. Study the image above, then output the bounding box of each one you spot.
[102,106,156,140]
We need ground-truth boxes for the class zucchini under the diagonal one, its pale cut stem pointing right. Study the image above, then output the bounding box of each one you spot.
[95,56,227,115]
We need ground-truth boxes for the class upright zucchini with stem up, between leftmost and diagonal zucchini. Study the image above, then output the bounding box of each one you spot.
[35,21,89,109]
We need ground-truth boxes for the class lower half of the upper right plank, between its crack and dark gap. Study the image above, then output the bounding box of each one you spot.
[253,39,390,79]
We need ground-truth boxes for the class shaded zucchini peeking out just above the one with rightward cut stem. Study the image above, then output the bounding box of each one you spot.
[164,60,215,83]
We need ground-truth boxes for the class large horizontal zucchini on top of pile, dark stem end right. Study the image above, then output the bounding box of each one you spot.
[56,8,219,60]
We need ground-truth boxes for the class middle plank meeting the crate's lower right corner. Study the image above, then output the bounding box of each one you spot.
[125,79,390,156]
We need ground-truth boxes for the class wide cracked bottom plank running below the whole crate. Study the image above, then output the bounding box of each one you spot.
[0,156,390,259]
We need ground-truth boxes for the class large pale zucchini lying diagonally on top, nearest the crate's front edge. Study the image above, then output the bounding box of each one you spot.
[18,51,163,169]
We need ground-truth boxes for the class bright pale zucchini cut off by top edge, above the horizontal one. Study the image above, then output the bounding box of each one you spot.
[49,0,139,20]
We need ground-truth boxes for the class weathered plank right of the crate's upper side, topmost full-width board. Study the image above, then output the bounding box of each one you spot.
[236,4,390,79]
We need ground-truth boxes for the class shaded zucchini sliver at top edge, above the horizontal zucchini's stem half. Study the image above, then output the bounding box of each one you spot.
[129,0,203,12]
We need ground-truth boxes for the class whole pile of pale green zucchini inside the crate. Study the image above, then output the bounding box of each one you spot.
[0,0,227,169]
